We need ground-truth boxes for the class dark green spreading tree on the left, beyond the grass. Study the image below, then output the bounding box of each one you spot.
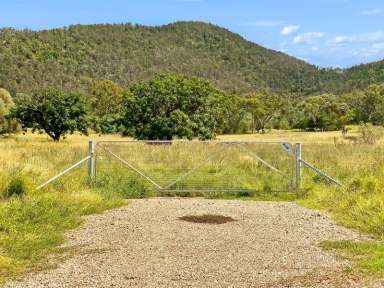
[11,89,88,141]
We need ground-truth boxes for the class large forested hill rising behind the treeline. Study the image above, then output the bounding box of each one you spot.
[0,22,382,94]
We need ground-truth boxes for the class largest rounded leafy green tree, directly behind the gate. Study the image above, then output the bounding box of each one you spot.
[123,75,227,140]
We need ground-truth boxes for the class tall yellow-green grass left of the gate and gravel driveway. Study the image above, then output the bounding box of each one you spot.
[0,135,124,283]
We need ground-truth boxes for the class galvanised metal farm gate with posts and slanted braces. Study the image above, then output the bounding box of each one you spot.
[38,140,342,192]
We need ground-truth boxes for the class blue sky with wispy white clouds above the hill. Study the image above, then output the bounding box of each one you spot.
[0,0,384,67]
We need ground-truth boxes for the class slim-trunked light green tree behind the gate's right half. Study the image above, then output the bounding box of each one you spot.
[243,90,281,133]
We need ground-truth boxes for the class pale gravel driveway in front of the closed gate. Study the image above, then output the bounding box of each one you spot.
[6,198,381,288]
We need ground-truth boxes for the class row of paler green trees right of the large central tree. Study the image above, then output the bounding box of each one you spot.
[224,84,384,133]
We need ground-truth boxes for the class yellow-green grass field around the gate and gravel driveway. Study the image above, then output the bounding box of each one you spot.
[0,131,384,282]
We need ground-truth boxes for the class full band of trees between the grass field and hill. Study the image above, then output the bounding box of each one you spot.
[0,74,384,141]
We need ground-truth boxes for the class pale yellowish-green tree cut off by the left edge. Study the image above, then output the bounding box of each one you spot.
[0,88,18,135]
